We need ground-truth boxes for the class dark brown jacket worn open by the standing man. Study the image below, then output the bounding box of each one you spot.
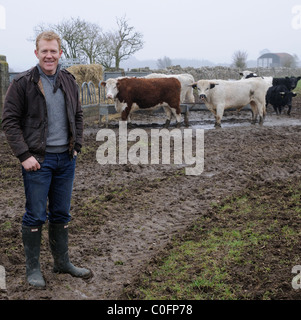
[2,67,83,162]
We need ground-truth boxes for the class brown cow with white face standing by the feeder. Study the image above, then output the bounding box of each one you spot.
[101,77,181,128]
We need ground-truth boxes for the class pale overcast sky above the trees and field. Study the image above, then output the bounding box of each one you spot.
[0,0,301,71]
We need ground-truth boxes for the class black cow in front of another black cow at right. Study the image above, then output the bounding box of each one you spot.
[266,84,297,115]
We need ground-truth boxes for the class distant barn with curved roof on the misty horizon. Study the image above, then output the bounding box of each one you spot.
[257,53,295,68]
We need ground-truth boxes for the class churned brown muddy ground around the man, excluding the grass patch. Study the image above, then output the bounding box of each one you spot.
[0,99,301,300]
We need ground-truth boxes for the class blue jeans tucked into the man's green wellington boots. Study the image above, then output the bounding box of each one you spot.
[22,151,76,226]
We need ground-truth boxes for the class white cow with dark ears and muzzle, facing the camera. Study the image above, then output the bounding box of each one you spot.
[193,79,267,128]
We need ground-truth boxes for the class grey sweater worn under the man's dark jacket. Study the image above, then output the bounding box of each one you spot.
[38,65,69,153]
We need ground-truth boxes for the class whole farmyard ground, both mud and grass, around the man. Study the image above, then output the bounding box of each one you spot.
[0,96,301,300]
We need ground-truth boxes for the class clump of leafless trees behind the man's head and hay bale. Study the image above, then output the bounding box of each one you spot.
[29,17,144,70]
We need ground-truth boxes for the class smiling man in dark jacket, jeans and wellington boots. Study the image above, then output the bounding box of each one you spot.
[2,31,91,288]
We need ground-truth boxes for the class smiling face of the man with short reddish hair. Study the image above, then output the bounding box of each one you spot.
[35,39,63,76]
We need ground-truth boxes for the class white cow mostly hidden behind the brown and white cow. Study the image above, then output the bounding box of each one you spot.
[145,73,195,103]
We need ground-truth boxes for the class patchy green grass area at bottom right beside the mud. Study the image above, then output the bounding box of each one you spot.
[126,182,301,300]
